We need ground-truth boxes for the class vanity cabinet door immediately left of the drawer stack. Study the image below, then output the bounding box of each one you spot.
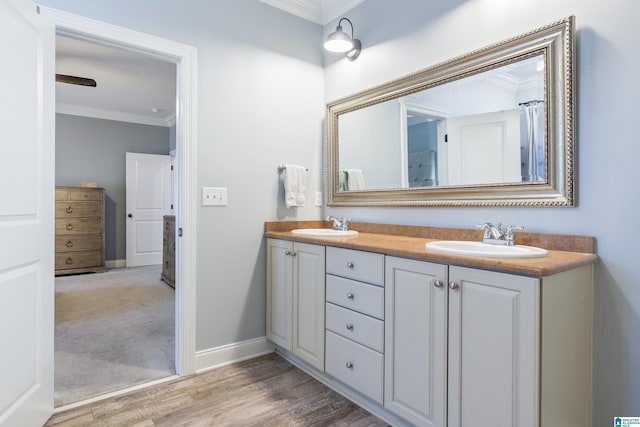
[293,242,325,371]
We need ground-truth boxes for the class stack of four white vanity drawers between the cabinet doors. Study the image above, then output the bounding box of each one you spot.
[325,247,384,404]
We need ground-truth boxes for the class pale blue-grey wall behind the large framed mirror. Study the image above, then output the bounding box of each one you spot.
[324,0,640,426]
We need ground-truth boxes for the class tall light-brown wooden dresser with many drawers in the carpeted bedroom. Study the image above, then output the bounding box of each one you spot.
[55,187,105,276]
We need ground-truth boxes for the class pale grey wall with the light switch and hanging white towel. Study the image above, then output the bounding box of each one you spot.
[40,0,324,350]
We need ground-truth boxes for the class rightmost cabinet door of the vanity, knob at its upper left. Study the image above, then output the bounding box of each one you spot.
[448,266,540,427]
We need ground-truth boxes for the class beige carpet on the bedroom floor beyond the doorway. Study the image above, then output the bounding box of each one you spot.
[54,266,175,407]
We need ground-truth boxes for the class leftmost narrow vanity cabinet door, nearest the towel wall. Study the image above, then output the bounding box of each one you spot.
[267,239,293,351]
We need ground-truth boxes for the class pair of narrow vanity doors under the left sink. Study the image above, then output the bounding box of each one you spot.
[267,239,325,371]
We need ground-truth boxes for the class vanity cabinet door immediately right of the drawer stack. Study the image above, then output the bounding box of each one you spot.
[384,257,444,426]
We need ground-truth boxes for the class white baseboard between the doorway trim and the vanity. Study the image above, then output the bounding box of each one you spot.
[196,337,275,374]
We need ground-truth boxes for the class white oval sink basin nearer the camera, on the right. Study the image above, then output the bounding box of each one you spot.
[425,240,547,258]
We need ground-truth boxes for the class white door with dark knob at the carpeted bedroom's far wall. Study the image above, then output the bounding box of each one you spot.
[126,153,171,267]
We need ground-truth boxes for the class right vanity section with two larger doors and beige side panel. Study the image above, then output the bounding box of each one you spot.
[384,256,592,427]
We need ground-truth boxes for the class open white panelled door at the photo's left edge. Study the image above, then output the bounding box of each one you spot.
[0,0,55,426]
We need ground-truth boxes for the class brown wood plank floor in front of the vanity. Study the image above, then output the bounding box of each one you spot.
[46,353,387,427]
